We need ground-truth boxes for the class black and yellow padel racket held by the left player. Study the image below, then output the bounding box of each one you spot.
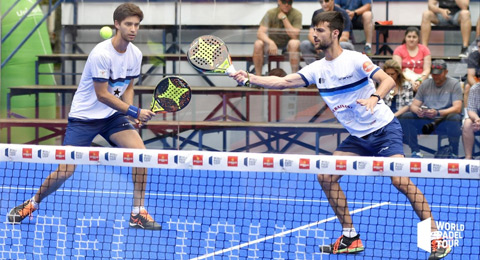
[150,76,192,113]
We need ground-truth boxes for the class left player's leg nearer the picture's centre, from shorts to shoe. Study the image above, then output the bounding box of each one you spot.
[106,114,162,230]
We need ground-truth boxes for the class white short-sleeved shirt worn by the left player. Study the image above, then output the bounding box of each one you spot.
[68,39,142,119]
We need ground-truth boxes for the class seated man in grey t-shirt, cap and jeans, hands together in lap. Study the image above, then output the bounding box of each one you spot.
[399,60,462,157]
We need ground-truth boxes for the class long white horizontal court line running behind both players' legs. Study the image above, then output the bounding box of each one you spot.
[0,186,480,210]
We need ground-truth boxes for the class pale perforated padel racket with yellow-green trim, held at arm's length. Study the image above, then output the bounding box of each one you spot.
[187,35,250,86]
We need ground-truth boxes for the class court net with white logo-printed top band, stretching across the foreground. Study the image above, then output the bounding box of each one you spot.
[0,144,480,259]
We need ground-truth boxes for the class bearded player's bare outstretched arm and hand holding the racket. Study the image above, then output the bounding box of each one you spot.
[230,70,306,89]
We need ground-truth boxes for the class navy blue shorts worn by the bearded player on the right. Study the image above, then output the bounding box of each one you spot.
[337,117,405,157]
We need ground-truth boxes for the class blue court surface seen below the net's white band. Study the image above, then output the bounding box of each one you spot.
[0,162,480,259]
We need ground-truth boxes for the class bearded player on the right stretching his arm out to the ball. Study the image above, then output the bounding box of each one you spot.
[230,12,451,259]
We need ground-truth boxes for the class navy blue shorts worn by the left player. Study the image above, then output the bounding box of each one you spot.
[63,112,135,146]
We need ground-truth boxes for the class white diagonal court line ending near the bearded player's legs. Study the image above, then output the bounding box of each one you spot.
[190,202,390,260]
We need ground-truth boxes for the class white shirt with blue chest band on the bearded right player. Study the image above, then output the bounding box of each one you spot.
[298,50,394,137]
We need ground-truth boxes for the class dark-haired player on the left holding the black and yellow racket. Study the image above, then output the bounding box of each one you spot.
[8,3,162,230]
